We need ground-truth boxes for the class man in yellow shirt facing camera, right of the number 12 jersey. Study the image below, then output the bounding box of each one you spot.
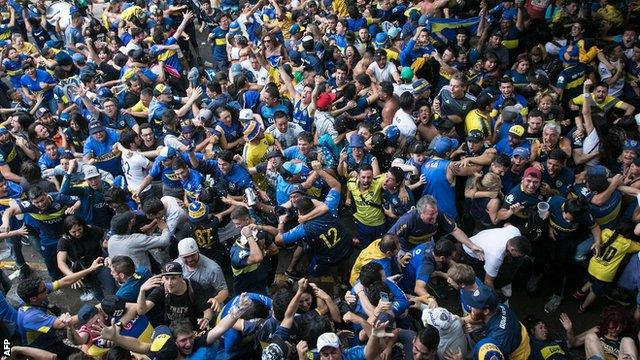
[345,165,387,247]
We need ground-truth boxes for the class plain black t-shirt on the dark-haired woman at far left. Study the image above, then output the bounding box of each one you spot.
[58,225,104,271]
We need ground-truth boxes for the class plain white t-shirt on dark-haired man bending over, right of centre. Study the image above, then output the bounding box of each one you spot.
[462,225,521,278]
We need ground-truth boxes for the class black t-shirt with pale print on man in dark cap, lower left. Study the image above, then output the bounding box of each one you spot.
[147,280,208,327]
